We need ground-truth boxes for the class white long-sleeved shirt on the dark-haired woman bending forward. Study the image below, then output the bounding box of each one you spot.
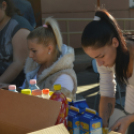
[97,61,134,114]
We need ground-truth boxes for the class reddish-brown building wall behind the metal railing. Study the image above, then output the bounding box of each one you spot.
[41,0,134,48]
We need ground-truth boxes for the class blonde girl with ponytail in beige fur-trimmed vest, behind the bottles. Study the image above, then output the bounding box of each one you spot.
[22,17,77,99]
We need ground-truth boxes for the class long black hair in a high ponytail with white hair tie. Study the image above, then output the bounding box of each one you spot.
[81,9,129,84]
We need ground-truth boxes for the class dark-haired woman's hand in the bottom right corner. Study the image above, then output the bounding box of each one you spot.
[110,115,134,134]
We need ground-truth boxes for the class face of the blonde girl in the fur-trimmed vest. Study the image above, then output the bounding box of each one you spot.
[28,38,51,64]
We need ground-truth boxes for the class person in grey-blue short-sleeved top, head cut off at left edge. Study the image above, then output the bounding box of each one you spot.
[0,0,33,88]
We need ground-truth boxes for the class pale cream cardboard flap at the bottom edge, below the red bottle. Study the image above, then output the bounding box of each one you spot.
[28,124,69,134]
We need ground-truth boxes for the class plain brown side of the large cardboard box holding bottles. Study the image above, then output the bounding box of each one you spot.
[0,90,69,134]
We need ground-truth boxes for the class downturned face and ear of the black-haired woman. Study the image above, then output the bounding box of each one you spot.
[83,38,119,67]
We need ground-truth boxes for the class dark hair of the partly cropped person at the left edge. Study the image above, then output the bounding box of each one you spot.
[0,0,21,17]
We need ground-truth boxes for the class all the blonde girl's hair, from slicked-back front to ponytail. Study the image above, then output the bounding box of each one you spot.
[27,17,62,51]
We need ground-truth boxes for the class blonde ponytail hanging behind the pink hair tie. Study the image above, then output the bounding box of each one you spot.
[45,17,62,51]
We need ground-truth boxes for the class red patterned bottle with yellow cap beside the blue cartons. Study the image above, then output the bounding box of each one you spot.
[50,84,68,128]
